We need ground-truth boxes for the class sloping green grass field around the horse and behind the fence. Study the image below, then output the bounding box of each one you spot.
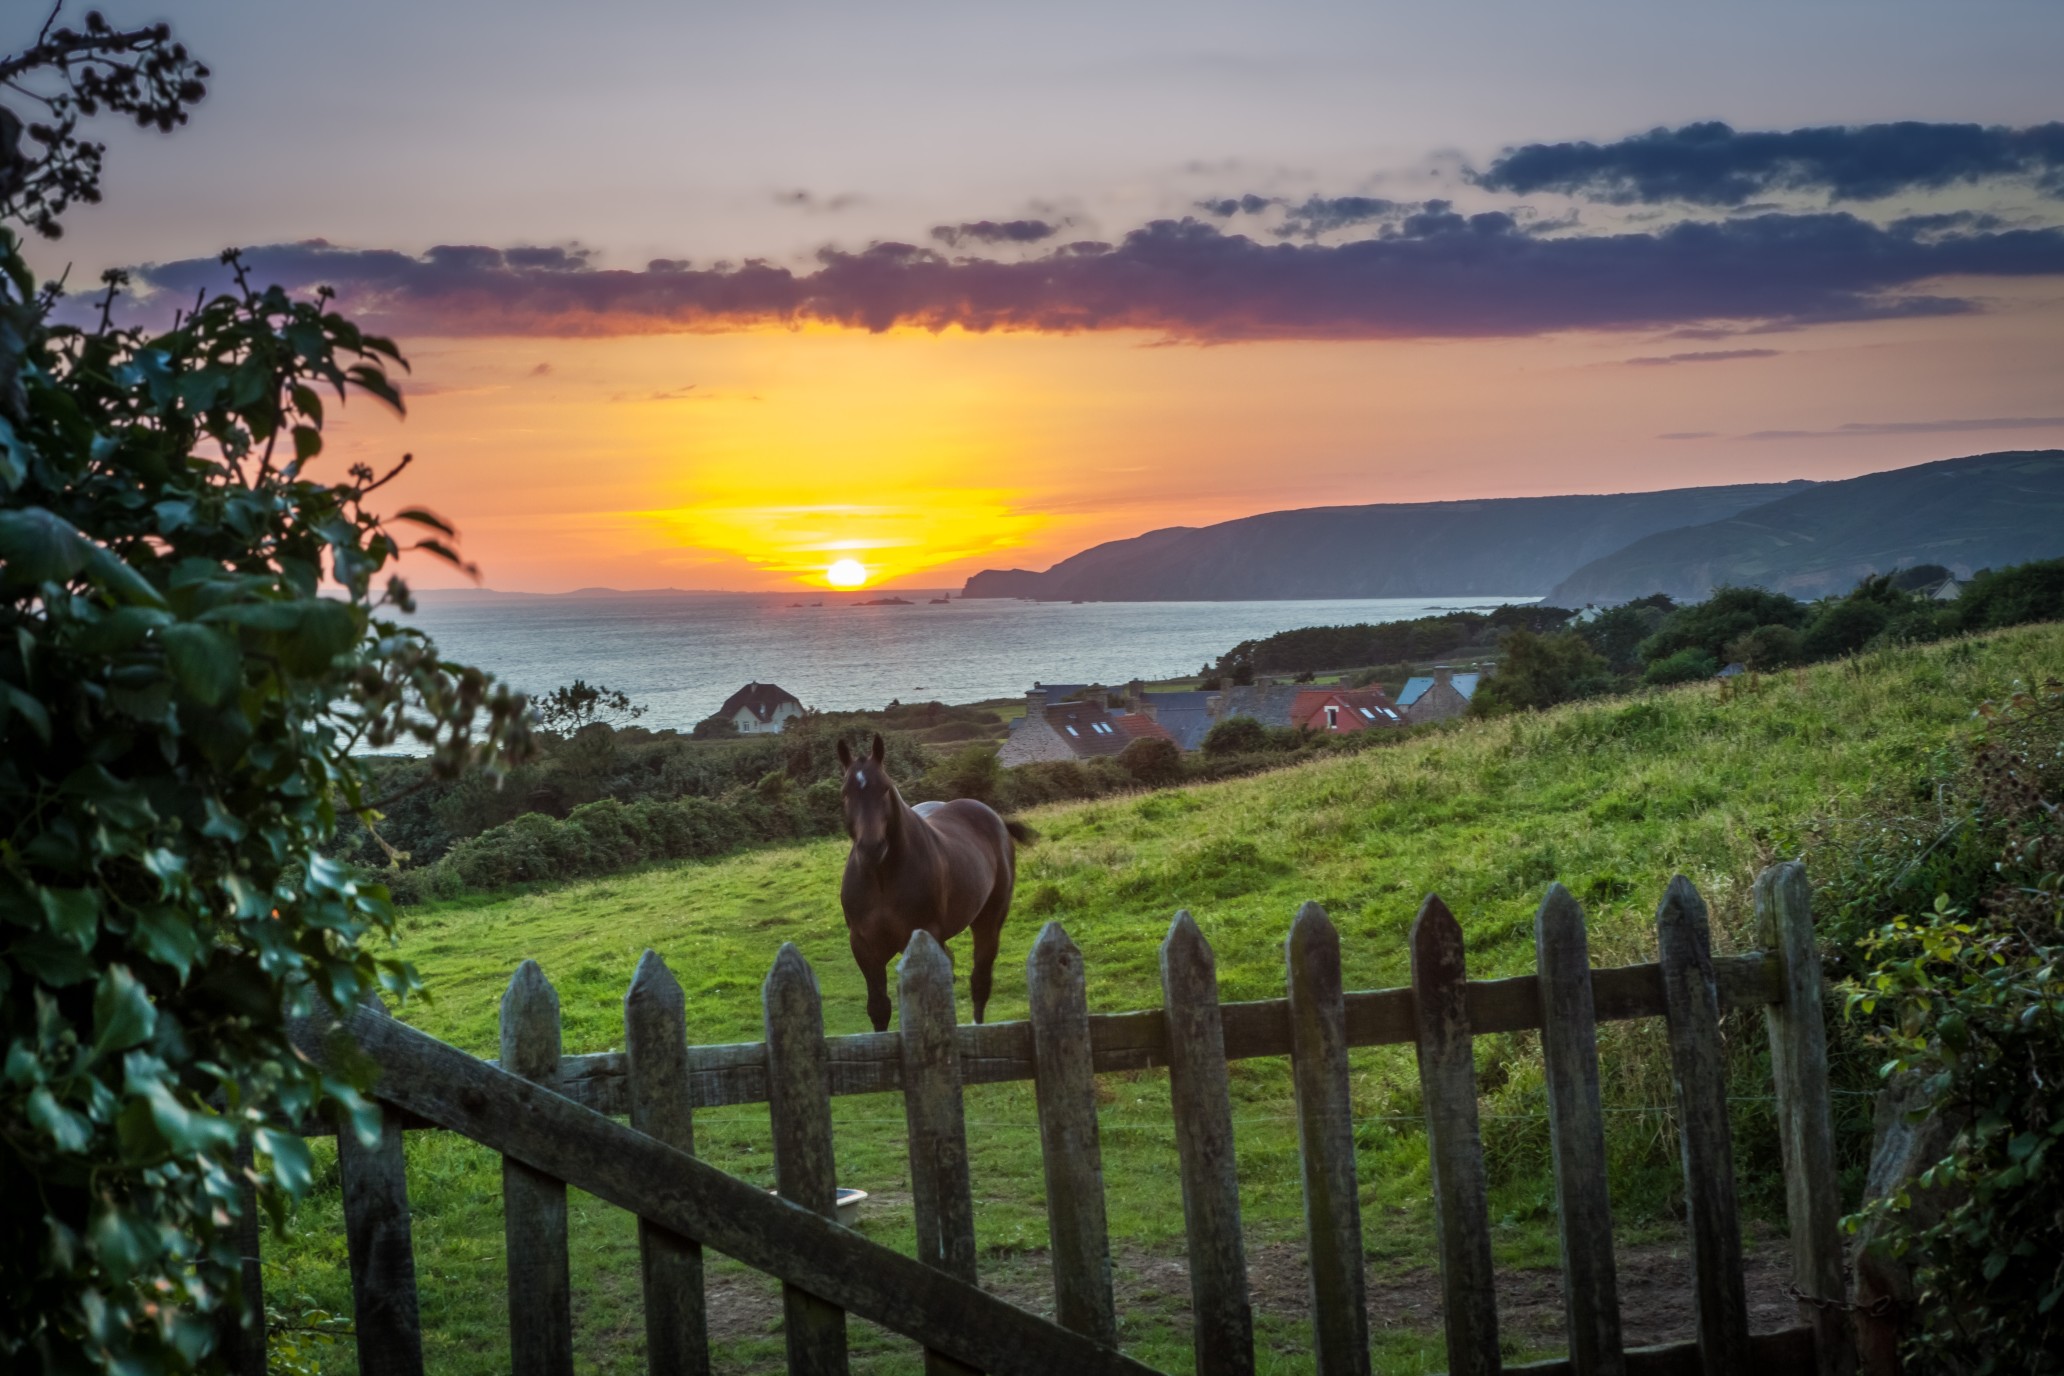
[266,627,2064,1374]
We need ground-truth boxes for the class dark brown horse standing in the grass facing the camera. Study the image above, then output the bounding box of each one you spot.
[838,736,1032,1031]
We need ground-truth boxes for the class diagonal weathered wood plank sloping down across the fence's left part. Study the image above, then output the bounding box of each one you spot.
[295,1015,1152,1376]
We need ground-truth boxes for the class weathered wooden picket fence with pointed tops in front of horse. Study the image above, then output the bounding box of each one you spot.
[248,864,1851,1376]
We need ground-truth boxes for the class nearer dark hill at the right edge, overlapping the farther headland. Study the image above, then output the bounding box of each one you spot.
[1548,450,2064,607]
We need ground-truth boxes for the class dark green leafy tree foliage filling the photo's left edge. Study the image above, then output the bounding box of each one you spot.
[0,19,526,1372]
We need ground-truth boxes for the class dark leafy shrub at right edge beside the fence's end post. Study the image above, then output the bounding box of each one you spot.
[1825,683,2064,1374]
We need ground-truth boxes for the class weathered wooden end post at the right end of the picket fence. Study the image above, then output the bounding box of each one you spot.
[1756,860,1856,1376]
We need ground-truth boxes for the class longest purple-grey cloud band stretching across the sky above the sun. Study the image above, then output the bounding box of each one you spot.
[117,213,2064,340]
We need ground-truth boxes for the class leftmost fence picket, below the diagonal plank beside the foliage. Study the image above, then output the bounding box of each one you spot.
[336,998,423,1376]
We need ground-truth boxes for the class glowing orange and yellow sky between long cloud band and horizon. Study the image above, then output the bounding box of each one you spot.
[332,279,2064,592]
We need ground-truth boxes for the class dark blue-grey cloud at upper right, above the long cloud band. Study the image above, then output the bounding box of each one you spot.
[1476,120,2064,206]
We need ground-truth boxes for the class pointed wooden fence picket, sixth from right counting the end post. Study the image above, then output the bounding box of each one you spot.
[1160,912,1255,1376]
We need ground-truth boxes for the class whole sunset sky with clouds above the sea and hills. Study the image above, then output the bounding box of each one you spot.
[24,0,2064,592]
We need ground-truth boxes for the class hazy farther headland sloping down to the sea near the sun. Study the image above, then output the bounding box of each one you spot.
[962,481,1812,602]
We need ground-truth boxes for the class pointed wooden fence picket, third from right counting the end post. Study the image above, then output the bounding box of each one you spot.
[1534,885,1626,1376]
